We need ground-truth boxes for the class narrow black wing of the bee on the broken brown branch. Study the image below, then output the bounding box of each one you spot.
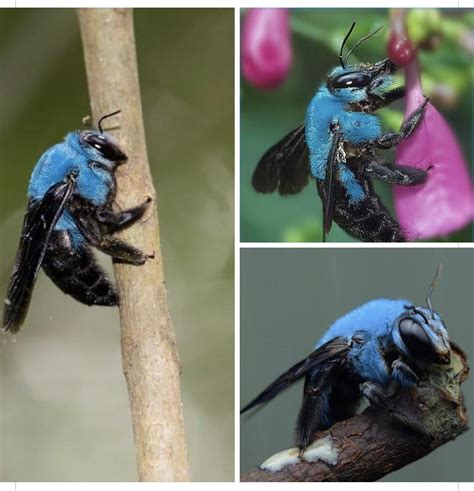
[240,337,350,413]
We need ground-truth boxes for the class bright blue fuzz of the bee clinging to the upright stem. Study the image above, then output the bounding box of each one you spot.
[28,131,114,245]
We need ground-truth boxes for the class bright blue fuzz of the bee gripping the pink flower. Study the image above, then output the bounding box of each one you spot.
[305,66,391,203]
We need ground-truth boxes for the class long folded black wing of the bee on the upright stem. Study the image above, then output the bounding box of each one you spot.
[3,173,77,332]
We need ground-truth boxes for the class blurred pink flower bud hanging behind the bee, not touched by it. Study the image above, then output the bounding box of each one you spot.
[242,9,292,89]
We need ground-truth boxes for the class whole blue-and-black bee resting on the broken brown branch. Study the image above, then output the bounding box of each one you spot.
[241,269,451,450]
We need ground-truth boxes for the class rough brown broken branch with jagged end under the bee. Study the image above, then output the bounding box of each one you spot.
[241,346,469,481]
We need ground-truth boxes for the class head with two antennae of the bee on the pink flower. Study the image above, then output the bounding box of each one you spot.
[327,22,397,102]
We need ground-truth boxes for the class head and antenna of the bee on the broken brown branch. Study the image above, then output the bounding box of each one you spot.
[393,268,451,365]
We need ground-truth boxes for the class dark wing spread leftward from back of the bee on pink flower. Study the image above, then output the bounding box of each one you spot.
[252,124,310,195]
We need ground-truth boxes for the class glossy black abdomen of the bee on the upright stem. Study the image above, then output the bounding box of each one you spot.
[42,231,119,306]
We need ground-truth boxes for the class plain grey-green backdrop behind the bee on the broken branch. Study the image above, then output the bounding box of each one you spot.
[240,248,474,481]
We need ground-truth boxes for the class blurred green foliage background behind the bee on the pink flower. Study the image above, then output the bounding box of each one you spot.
[240,9,474,242]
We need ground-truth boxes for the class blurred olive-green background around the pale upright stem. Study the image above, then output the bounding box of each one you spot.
[0,9,234,481]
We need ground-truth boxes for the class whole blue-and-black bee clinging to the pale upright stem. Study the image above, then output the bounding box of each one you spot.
[3,111,152,332]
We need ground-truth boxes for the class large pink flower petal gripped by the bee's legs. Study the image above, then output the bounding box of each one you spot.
[394,58,474,240]
